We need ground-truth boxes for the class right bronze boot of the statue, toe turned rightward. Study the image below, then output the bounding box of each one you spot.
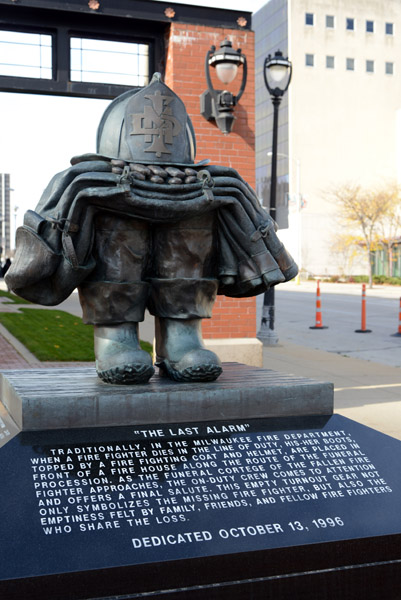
[155,317,222,382]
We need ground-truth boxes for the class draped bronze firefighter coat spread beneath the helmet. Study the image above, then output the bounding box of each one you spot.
[6,154,297,305]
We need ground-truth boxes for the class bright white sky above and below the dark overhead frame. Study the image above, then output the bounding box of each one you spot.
[0,0,266,246]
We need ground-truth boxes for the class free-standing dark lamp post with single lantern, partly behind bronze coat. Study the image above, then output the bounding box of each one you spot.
[258,50,292,346]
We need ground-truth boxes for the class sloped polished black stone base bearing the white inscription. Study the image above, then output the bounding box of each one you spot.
[0,415,401,600]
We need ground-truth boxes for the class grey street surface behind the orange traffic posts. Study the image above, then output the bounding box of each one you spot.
[276,282,401,367]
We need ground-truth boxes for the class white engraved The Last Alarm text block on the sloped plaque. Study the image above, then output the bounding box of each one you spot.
[30,424,392,548]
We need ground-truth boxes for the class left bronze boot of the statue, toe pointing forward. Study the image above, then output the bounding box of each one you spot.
[94,323,155,385]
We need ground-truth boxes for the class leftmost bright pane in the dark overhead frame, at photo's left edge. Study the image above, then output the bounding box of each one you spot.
[0,30,52,79]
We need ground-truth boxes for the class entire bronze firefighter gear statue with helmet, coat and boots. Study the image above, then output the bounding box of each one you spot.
[6,74,297,384]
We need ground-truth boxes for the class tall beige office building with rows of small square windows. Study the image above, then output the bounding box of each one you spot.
[253,0,401,275]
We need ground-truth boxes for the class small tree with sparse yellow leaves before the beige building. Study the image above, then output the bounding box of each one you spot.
[330,183,394,287]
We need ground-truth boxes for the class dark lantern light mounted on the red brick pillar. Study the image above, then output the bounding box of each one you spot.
[201,40,247,134]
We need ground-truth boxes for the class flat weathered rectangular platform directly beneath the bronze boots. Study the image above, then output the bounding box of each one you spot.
[1,363,333,431]
